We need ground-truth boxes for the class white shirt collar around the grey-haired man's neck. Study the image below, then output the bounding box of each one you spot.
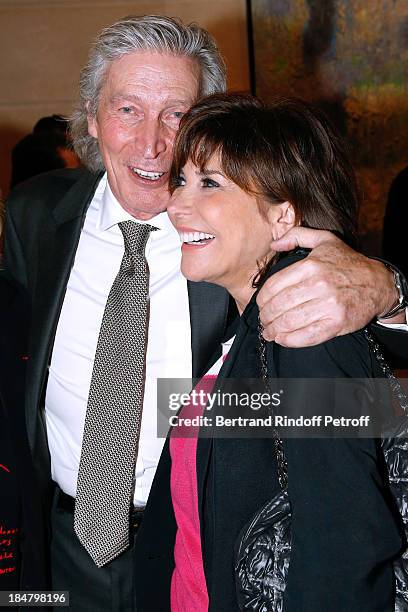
[97,172,175,234]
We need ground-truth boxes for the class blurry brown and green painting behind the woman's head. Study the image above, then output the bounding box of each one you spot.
[252,0,408,253]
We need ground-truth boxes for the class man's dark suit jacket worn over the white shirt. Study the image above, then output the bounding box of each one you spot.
[5,170,235,612]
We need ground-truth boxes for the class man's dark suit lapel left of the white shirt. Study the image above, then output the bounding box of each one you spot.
[26,174,100,448]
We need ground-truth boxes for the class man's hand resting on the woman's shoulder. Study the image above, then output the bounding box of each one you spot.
[257,227,405,347]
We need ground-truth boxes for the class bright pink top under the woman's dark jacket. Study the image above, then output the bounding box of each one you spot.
[170,339,233,612]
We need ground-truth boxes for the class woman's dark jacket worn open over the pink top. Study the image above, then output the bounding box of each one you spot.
[136,257,404,612]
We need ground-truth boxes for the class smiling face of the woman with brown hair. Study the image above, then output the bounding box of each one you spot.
[167,155,274,299]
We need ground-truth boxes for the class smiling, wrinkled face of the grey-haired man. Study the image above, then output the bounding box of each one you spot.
[88,51,200,220]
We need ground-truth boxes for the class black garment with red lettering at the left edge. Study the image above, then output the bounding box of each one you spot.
[0,273,49,590]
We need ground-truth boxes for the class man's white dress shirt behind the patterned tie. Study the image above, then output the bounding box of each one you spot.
[45,174,192,506]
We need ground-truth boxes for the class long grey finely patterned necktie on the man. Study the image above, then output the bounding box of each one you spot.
[74,221,157,567]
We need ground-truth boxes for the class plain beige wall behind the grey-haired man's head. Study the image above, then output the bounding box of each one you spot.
[0,0,249,195]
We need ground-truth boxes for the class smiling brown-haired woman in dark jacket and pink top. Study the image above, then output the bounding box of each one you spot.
[164,94,402,612]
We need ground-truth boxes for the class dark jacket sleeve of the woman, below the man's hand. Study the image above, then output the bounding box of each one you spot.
[268,333,403,612]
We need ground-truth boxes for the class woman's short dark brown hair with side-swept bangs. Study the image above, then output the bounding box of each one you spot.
[170,94,357,253]
